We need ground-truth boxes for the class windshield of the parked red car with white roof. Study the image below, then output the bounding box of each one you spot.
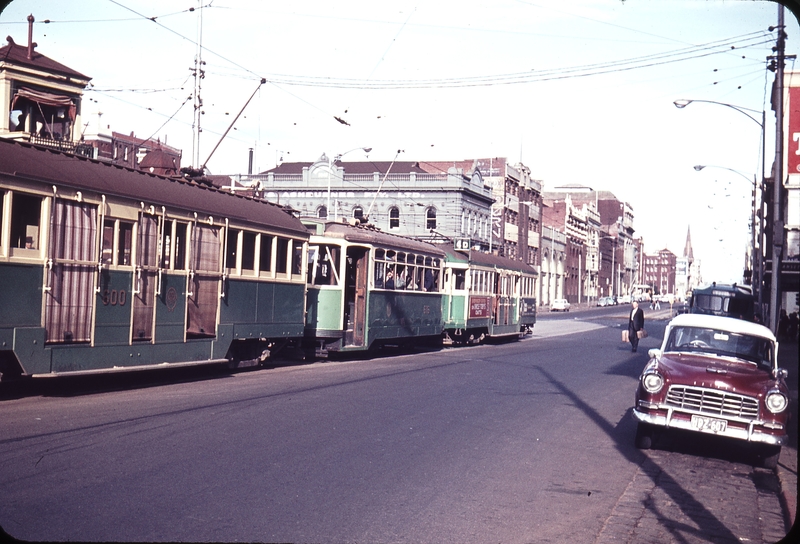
[665,327,773,370]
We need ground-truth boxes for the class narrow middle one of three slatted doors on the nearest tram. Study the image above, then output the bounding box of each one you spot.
[132,213,158,341]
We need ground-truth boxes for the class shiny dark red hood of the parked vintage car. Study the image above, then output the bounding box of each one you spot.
[658,353,786,396]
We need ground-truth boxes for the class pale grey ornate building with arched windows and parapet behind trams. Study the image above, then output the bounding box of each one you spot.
[244,154,493,250]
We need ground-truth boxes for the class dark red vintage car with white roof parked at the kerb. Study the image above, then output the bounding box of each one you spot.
[633,314,789,468]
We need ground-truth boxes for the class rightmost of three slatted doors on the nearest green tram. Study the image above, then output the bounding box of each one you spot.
[186,223,222,338]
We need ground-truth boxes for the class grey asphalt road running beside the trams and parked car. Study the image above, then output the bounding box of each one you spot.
[0,309,782,542]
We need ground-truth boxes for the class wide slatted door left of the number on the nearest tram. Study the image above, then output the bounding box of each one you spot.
[45,198,98,343]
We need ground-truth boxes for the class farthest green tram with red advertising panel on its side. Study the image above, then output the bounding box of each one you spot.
[442,248,537,344]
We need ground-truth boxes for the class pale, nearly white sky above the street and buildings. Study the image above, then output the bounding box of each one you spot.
[0,0,800,281]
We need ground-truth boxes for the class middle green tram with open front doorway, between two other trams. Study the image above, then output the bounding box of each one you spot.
[304,219,444,355]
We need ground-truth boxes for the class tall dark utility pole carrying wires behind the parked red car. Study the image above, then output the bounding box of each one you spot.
[768,4,786,334]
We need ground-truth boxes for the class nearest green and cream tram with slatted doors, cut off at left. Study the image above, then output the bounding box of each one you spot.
[0,139,309,377]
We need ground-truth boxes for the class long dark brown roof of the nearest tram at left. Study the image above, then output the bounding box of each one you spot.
[0,138,308,238]
